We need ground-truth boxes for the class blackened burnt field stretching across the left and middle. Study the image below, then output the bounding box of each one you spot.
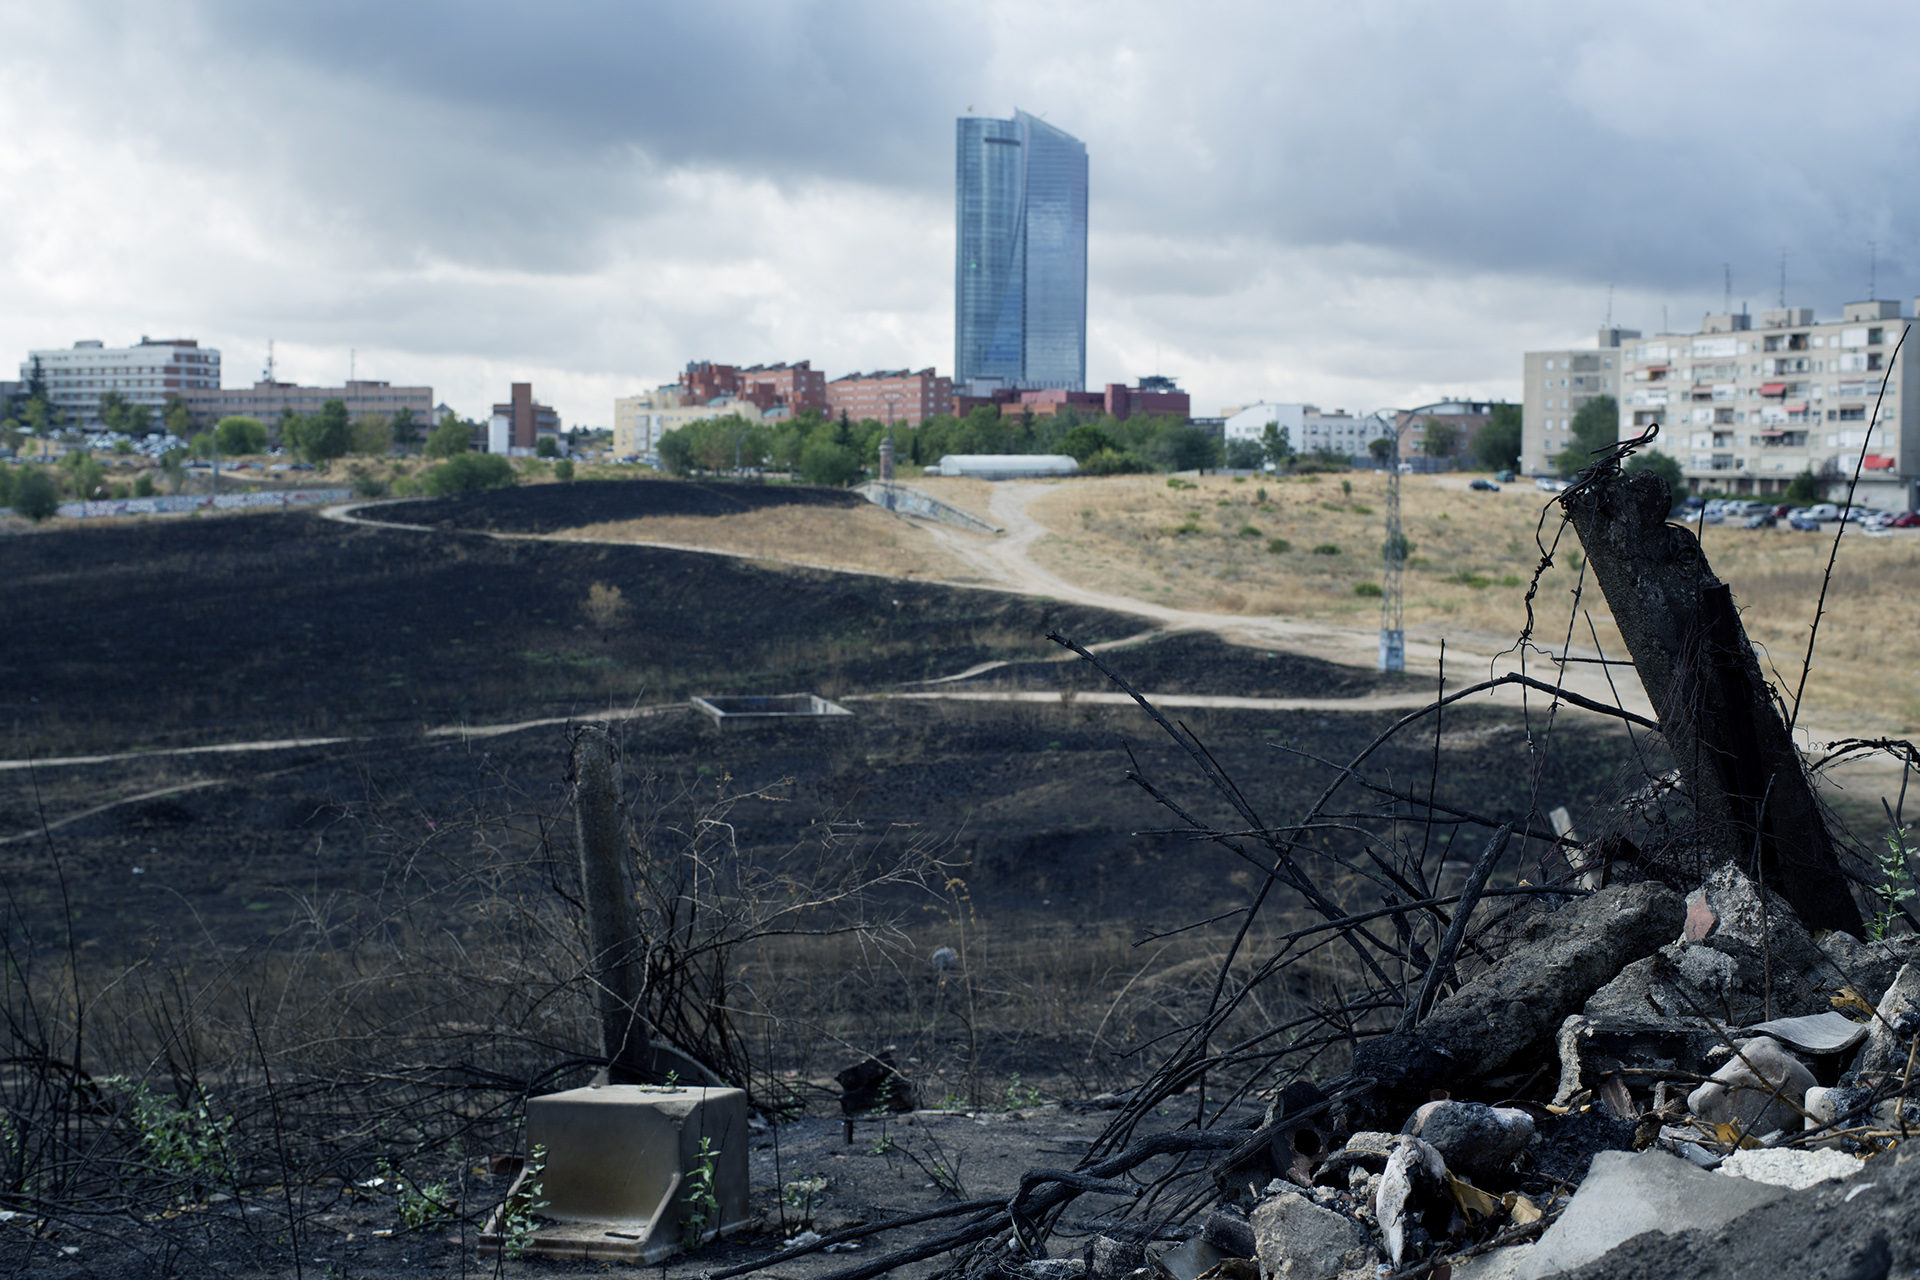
[0,484,1647,1274]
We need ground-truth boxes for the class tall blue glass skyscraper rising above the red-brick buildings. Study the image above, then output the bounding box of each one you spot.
[954,111,1087,391]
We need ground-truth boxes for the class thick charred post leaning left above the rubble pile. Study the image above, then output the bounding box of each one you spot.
[1561,462,1860,936]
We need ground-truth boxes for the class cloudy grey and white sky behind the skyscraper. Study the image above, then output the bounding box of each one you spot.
[0,0,1920,426]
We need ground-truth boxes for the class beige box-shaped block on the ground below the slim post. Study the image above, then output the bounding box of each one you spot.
[515,1084,747,1263]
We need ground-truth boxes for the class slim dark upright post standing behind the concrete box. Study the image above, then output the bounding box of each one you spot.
[574,725,653,1084]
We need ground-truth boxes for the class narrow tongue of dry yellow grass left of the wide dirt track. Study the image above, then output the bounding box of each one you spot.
[557,505,977,581]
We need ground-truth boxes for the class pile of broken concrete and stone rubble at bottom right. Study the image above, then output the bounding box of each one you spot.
[1054,865,1920,1280]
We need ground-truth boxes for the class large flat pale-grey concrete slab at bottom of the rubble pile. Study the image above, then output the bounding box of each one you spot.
[1453,1151,1788,1280]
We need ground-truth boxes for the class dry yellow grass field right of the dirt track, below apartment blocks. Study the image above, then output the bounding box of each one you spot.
[916,472,1920,729]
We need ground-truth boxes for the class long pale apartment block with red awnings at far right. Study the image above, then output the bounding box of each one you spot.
[1620,301,1920,510]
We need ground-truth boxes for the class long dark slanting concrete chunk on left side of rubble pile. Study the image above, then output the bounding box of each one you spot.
[1354,881,1686,1119]
